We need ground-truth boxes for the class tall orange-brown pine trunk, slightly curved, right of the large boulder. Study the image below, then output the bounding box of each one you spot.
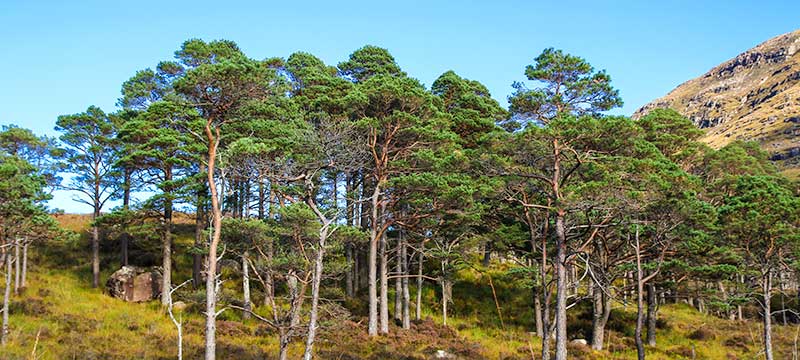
[205,124,222,360]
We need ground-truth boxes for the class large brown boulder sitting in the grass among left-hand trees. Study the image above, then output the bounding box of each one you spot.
[106,266,162,302]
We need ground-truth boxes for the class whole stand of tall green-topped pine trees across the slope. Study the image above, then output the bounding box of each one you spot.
[0,39,800,359]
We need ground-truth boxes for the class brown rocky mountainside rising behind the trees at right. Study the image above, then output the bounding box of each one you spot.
[633,30,800,172]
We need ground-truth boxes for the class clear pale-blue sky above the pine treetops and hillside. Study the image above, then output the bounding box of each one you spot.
[0,0,800,212]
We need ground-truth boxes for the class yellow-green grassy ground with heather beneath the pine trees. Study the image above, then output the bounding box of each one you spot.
[0,218,800,360]
